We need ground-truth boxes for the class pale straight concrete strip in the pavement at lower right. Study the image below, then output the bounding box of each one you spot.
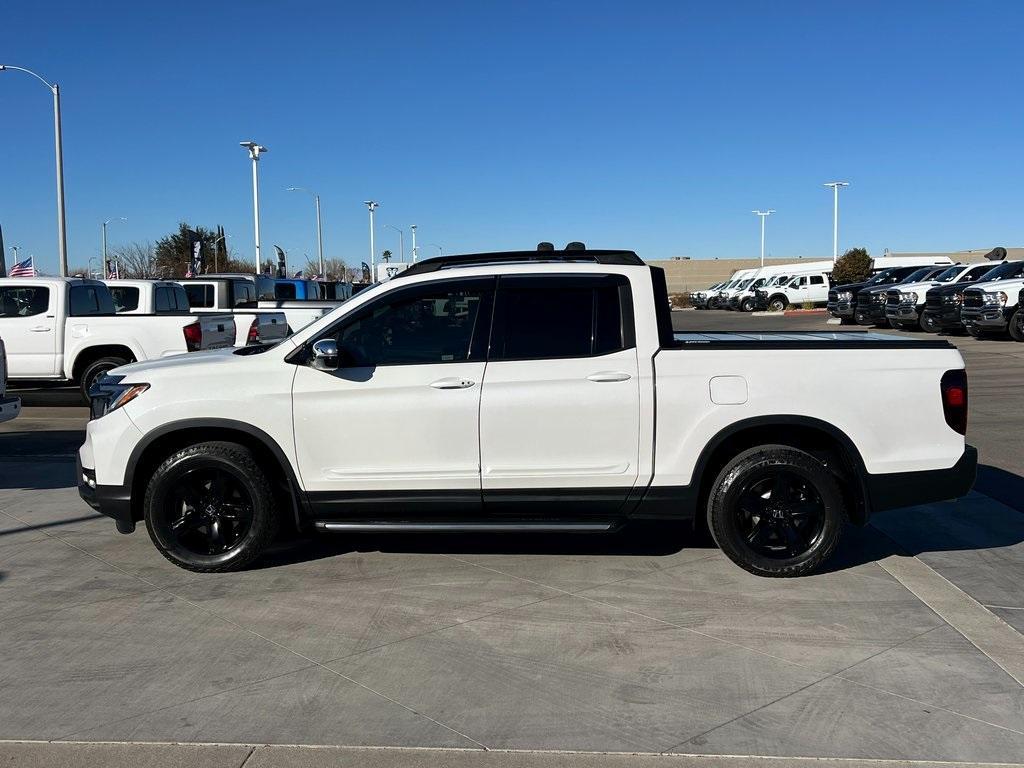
[879,555,1024,686]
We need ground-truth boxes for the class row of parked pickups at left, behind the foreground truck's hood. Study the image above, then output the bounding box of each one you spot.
[0,273,351,396]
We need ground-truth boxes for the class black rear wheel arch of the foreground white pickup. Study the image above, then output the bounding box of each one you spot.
[693,416,869,525]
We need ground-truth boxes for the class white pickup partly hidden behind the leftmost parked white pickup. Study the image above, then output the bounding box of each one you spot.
[103,280,288,347]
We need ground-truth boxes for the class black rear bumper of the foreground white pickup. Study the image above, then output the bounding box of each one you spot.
[864,445,978,512]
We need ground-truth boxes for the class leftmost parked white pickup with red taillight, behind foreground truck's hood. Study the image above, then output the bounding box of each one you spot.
[0,278,234,396]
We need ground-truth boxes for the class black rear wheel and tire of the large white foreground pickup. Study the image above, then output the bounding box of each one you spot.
[708,445,846,577]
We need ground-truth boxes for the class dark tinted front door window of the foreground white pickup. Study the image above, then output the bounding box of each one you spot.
[332,280,494,368]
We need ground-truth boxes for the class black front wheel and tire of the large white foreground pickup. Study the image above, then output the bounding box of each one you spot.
[143,442,278,573]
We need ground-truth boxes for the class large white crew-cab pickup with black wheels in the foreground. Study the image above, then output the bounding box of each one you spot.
[78,250,977,577]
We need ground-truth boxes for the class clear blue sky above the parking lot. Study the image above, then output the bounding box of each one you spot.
[0,0,1024,270]
